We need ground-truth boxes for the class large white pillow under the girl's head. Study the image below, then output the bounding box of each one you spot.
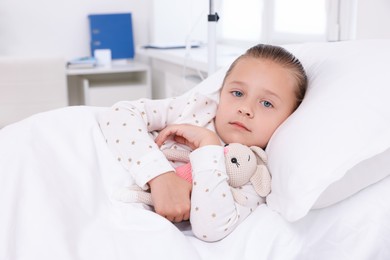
[266,40,390,221]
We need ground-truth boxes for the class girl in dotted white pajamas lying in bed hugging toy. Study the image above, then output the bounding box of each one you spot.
[99,44,307,241]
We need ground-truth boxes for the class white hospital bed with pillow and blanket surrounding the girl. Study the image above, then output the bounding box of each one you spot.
[0,40,390,260]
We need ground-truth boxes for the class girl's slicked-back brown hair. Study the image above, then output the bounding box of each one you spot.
[222,44,308,109]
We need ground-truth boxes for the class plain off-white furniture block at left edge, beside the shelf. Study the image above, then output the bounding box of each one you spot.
[0,57,68,128]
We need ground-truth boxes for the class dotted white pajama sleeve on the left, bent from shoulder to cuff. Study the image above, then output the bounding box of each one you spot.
[98,94,216,189]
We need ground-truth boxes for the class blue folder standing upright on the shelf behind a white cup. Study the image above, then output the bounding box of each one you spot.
[88,13,134,59]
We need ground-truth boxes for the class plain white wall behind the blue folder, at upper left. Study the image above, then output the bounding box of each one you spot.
[0,0,151,59]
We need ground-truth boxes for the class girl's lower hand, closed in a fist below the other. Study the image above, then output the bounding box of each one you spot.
[149,172,192,222]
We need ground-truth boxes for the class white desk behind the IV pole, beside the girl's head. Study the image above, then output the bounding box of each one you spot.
[136,45,245,98]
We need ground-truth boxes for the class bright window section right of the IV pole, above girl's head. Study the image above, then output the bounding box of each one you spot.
[218,0,338,44]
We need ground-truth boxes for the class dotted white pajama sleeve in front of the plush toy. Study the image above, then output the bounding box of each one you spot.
[190,146,262,242]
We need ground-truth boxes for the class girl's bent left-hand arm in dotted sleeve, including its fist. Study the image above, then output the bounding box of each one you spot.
[99,94,216,222]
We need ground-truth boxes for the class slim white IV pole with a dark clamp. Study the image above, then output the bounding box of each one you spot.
[207,0,219,76]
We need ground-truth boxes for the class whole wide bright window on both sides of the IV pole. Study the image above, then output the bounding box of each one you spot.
[151,0,358,47]
